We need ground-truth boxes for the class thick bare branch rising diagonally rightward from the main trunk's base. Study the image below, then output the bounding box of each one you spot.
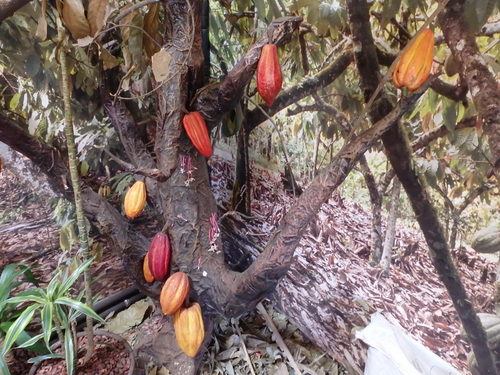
[226,88,425,314]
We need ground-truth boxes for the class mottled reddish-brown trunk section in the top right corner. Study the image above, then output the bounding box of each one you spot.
[438,0,500,174]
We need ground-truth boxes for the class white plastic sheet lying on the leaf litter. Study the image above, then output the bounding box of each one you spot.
[356,312,460,375]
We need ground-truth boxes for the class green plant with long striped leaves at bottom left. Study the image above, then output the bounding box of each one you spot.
[0,259,104,375]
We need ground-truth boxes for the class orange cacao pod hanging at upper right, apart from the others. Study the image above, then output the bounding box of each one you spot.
[392,29,434,91]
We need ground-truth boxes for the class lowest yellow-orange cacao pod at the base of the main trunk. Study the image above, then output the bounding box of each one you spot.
[173,302,205,358]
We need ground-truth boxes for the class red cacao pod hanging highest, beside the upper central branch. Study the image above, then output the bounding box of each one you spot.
[257,44,283,107]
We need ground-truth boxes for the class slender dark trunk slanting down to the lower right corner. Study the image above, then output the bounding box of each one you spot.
[347,0,496,375]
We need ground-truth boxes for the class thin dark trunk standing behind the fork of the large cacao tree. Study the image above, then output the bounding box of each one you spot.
[231,125,251,216]
